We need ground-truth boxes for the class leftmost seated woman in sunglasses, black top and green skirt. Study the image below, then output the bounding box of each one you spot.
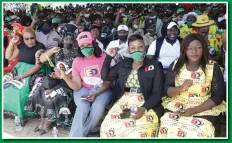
[4,28,45,118]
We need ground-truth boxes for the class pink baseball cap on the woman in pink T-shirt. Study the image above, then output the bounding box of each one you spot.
[77,31,94,47]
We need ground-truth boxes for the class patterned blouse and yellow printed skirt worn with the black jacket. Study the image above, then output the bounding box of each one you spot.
[100,70,158,138]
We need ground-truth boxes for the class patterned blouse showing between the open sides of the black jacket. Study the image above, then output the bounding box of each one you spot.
[125,70,140,88]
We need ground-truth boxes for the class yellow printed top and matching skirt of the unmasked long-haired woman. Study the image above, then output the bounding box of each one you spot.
[159,61,226,138]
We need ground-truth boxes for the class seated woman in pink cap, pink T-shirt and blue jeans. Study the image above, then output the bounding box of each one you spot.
[54,32,112,137]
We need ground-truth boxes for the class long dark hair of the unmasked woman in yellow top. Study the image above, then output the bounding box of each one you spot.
[173,34,209,76]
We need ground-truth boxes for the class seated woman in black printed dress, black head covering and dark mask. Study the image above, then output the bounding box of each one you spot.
[25,23,77,135]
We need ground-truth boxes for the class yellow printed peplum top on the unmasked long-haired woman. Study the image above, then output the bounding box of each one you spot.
[162,61,226,116]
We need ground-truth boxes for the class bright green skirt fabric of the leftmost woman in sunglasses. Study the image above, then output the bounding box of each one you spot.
[3,62,48,118]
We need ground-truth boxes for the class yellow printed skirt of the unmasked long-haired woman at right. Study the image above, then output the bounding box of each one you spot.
[158,112,215,138]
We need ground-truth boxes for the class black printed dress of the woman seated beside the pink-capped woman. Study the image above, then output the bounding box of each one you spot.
[24,49,77,127]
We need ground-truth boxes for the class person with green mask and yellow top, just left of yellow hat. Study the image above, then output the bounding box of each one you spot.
[179,12,198,39]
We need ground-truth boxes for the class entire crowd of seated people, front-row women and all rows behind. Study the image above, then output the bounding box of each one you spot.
[3,3,228,138]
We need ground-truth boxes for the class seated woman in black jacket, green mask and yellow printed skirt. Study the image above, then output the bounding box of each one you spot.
[101,35,164,138]
